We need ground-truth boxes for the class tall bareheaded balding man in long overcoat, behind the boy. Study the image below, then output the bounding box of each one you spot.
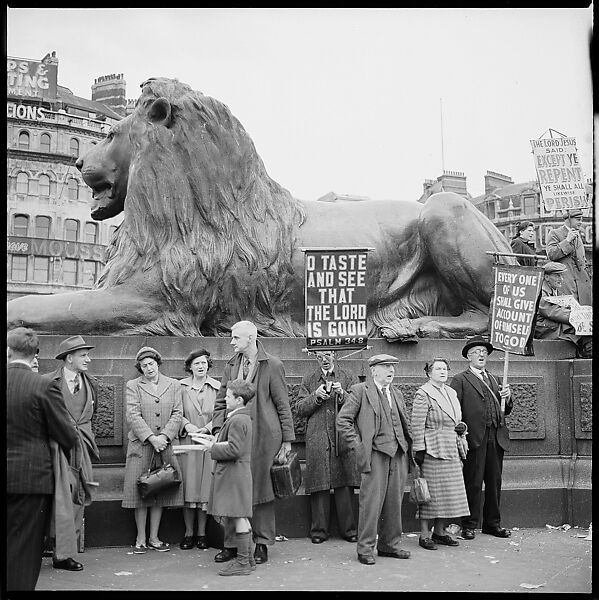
[212,321,295,563]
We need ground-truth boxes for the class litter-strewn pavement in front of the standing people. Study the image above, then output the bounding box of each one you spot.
[31,525,592,598]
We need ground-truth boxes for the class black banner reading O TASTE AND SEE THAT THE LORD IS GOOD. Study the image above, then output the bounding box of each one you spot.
[304,248,368,350]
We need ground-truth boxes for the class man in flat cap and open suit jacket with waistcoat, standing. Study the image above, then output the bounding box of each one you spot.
[337,354,413,565]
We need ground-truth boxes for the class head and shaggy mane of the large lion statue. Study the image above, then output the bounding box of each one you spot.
[77,78,304,335]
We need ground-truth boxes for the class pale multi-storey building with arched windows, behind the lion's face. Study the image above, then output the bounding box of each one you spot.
[6,53,124,300]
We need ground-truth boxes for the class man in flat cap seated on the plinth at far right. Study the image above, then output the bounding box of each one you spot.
[534,261,593,358]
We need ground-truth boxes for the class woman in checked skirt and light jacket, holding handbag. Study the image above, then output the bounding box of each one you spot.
[412,358,470,550]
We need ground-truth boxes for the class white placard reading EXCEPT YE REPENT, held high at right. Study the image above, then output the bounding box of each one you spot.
[530,137,589,211]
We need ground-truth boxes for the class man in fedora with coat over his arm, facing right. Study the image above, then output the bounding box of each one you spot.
[45,335,100,571]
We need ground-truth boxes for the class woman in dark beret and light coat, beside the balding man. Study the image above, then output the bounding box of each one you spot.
[179,348,220,550]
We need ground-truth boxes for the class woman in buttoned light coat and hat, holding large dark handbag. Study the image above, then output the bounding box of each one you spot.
[122,346,183,554]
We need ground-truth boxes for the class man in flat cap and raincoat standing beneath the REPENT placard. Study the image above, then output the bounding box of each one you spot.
[546,208,593,306]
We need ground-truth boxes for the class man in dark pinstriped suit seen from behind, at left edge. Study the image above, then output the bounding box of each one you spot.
[6,327,77,590]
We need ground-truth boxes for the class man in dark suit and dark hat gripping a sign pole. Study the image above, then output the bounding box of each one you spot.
[450,336,512,540]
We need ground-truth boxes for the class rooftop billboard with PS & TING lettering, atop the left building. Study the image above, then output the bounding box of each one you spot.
[6,56,58,100]
